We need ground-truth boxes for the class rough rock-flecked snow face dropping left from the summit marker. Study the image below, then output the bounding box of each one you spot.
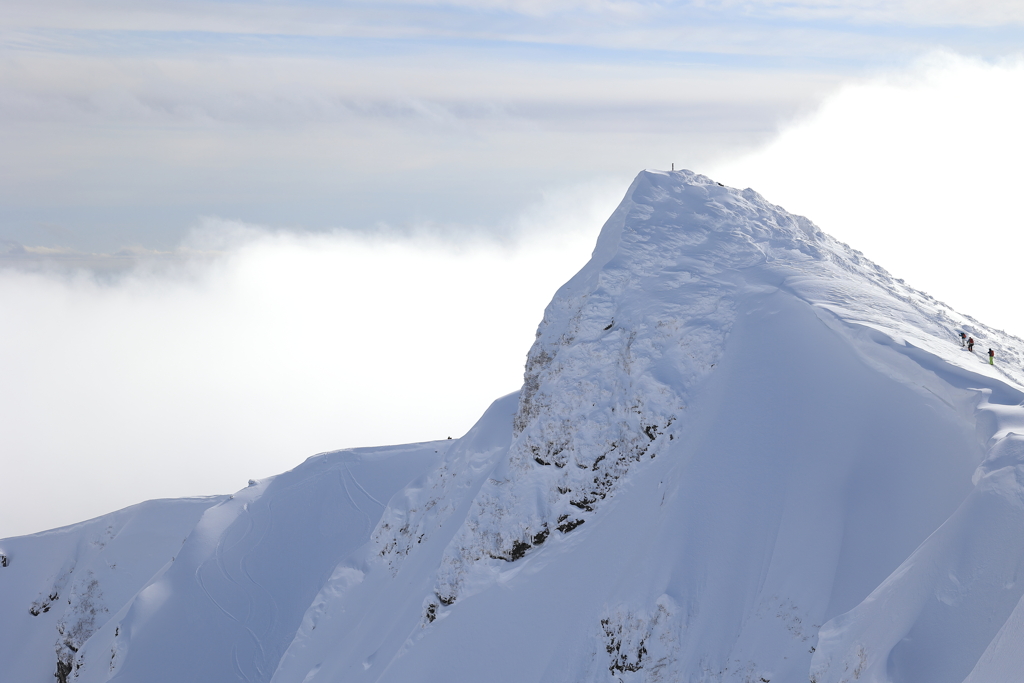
[428,173,807,603]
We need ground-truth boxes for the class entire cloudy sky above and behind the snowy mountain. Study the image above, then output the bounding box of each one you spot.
[0,0,1024,537]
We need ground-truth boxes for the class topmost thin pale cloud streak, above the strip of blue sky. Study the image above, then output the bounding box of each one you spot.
[12,0,1024,37]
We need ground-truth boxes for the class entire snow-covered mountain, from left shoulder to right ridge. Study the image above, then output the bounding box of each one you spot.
[0,171,1024,683]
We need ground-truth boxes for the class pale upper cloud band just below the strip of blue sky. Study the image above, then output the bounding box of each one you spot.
[0,53,840,129]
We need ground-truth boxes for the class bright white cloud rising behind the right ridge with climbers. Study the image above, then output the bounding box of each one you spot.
[714,54,1024,335]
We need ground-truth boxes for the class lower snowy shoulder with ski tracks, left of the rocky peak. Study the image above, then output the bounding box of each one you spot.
[0,441,456,681]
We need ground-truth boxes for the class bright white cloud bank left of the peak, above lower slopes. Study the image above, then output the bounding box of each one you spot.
[0,181,617,537]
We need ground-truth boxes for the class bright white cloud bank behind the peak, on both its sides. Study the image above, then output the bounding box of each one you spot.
[0,53,1024,537]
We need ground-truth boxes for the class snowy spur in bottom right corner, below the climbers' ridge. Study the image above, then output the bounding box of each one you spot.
[811,401,1024,683]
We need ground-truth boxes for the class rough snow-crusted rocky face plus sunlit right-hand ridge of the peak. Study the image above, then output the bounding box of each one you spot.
[428,171,1024,604]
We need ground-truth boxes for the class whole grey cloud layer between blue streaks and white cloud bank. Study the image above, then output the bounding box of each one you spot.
[0,47,827,252]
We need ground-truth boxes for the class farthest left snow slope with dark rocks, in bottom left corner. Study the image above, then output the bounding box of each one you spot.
[0,496,227,682]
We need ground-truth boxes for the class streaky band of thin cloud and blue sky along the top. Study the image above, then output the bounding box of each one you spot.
[8,0,1024,69]
